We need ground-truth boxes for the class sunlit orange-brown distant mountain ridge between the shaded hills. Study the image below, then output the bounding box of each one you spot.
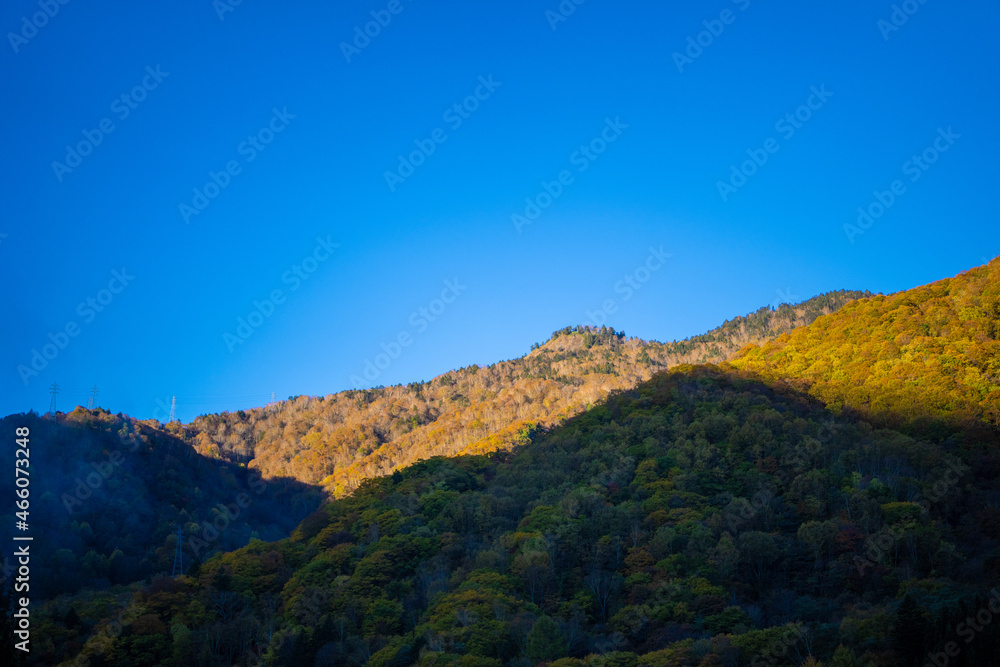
[191,291,870,495]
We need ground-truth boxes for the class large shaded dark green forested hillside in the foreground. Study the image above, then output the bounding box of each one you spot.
[56,367,1000,667]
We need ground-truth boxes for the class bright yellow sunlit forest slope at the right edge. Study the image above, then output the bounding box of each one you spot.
[731,258,1000,426]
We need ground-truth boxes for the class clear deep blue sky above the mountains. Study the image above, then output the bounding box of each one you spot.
[0,0,1000,421]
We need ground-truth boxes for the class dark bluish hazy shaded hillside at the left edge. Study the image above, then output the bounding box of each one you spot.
[0,408,321,601]
